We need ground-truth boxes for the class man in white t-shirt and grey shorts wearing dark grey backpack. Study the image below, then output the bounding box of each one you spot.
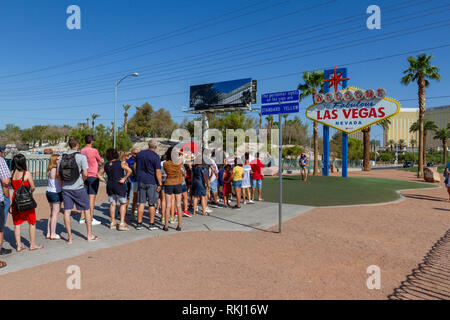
[58,138,99,243]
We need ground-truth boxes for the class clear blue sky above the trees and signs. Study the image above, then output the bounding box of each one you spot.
[0,0,450,140]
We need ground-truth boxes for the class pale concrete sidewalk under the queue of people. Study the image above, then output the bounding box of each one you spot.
[0,202,312,275]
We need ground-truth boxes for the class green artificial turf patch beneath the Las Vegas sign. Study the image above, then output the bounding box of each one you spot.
[263,176,434,207]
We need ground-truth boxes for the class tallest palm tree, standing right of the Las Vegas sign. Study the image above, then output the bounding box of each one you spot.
[401,53,441,177]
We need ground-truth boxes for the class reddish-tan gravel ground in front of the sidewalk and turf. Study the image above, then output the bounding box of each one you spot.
[0,170,450,300]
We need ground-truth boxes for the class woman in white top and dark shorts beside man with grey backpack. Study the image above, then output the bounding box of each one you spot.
[46,154,62,240]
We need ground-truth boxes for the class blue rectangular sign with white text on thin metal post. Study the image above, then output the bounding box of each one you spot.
[261,90,300,233]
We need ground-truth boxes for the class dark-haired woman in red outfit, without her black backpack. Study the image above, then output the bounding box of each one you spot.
[10,154,43,252]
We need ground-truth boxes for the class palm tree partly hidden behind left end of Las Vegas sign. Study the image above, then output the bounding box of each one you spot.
[298,71,324,175]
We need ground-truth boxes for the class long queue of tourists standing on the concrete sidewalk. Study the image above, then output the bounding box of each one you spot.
[0,135,264,268]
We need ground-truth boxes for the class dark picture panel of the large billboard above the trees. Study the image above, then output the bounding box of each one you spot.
[189,78,256,111]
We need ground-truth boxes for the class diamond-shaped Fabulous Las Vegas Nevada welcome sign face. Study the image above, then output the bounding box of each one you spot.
[306,87,400,133]
